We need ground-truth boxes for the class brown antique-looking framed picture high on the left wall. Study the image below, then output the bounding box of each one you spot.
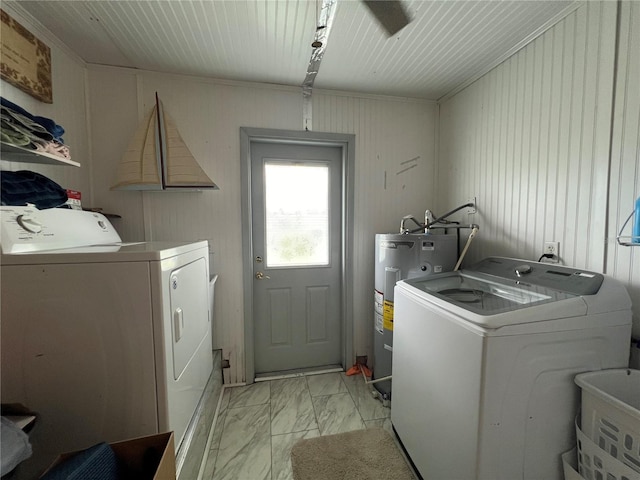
[0,9,53,103]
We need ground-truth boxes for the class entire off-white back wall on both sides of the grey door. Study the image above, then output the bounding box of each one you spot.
[88,66,436,382]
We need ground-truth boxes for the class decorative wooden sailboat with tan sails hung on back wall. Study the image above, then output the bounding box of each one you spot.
[111,93,218,191]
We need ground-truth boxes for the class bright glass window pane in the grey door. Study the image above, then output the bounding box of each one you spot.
[264,162,329,267]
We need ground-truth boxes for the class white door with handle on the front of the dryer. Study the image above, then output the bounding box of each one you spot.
[169,258,209,380]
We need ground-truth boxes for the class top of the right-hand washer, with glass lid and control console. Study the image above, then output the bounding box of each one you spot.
[396,257,631,334]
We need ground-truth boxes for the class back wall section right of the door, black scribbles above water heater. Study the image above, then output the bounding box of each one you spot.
[313,92,437,376]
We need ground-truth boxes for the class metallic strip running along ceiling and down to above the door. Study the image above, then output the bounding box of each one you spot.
[302,0,338,131]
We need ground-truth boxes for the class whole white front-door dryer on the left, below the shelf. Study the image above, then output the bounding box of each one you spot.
[0,206,213,478]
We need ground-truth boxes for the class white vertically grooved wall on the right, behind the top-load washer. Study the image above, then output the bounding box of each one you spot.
[437,1,640,338]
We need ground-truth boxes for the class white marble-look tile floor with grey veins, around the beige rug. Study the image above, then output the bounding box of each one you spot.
[202,373,402,480]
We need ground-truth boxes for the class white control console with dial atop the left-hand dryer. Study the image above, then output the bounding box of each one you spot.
[0,206,122,254]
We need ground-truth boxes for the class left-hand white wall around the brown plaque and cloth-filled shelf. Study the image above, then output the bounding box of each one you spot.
[0,5,94,206]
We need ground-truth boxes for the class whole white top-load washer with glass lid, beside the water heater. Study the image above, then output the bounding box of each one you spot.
[391,258,631,480]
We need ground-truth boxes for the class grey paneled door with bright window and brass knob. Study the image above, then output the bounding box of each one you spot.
[251,143,343,374]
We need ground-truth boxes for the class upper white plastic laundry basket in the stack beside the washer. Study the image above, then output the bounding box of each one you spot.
[575,369,640,478]
